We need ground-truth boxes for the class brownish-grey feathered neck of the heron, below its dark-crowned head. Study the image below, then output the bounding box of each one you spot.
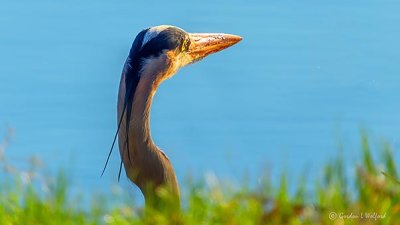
[118,54,179,207]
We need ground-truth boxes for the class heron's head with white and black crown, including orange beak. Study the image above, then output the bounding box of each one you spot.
[131,25,242,81]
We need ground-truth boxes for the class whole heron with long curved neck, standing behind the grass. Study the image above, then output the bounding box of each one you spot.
[102,25,242,209]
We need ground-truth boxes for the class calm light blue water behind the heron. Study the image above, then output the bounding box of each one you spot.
[0,0,400,199]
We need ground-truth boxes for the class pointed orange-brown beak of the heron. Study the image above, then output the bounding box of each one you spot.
[188,33,242,61]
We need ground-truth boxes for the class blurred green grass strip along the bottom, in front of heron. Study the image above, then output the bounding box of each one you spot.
[0,131,400,225]
